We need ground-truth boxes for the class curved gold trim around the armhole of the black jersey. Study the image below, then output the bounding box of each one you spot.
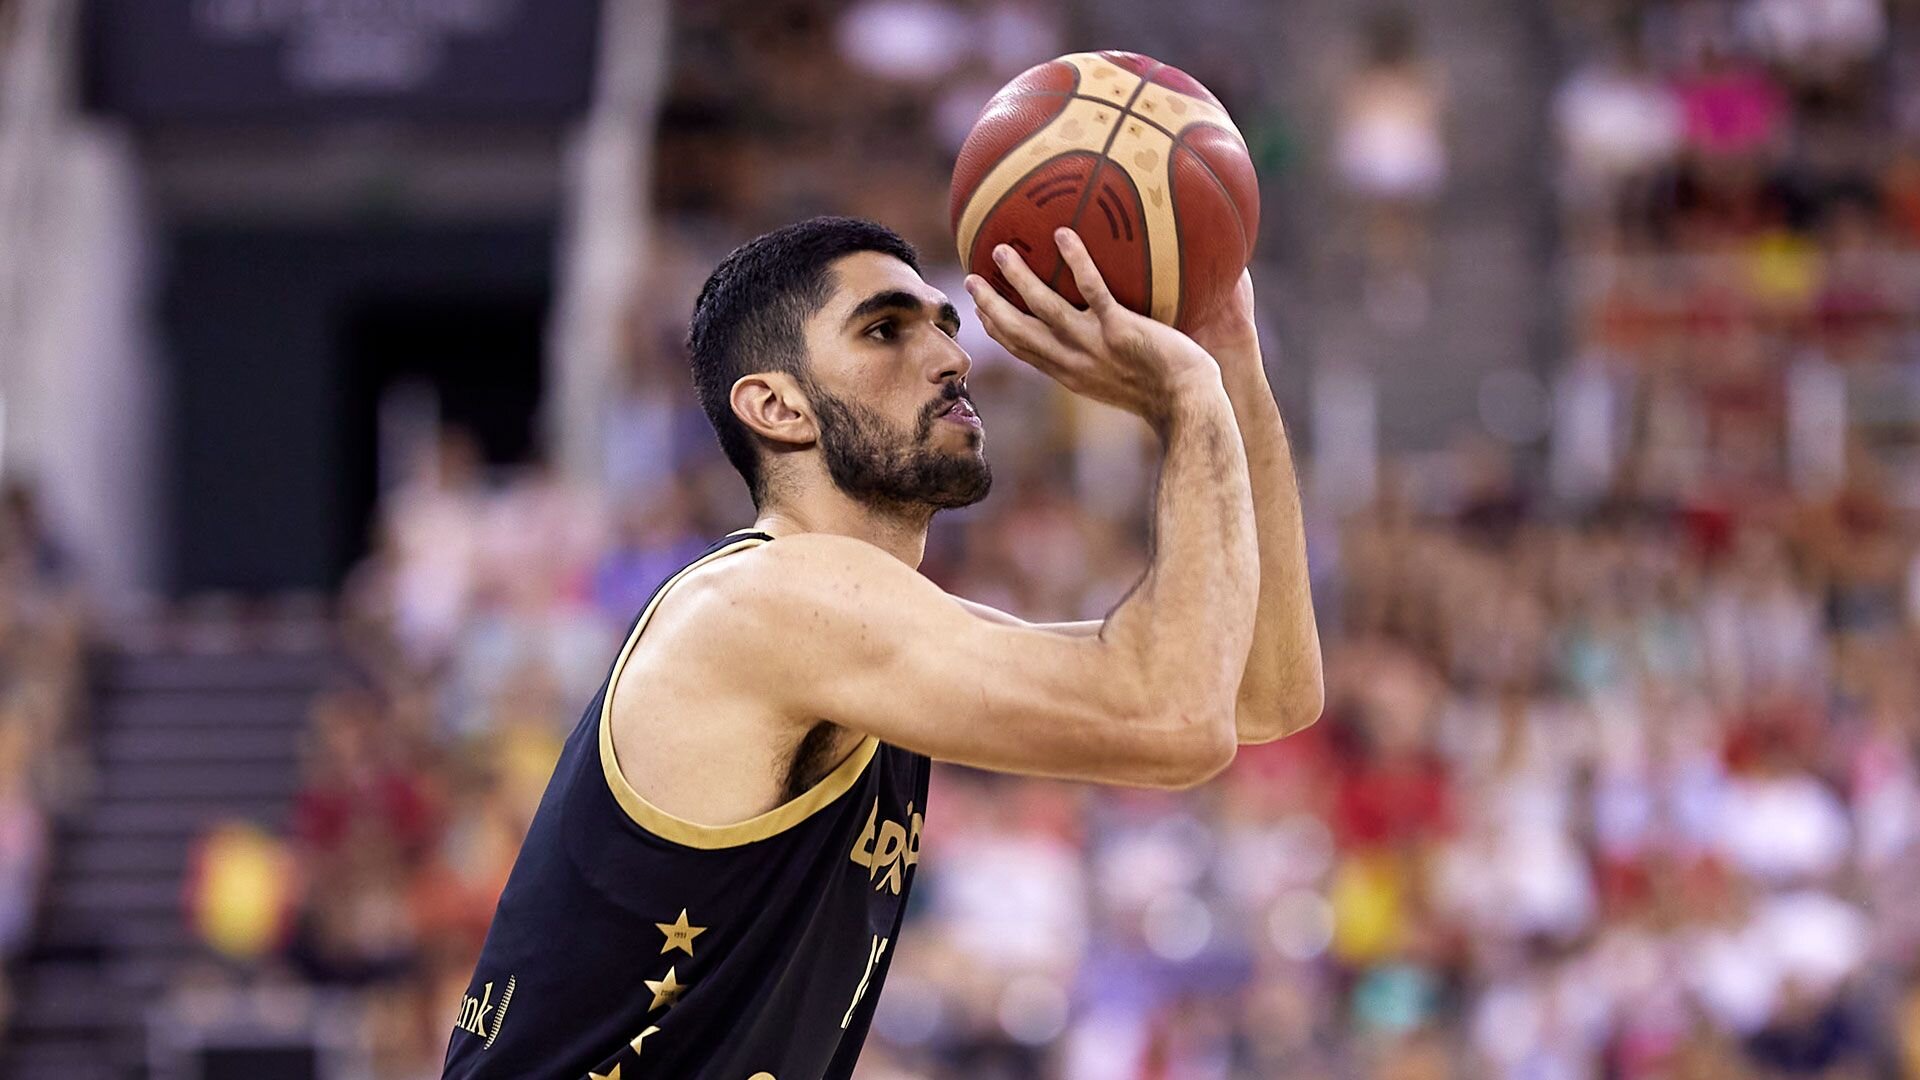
[599,536,879,849]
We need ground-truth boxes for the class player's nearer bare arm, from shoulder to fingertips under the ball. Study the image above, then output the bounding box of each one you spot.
[722,228,1260,786]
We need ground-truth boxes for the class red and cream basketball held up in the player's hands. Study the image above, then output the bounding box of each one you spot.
[948,52,1260,331]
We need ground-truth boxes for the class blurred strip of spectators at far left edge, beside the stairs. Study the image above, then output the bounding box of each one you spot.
[0,479,86,1032]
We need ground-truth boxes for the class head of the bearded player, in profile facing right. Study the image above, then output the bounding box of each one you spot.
[687,217,993,511]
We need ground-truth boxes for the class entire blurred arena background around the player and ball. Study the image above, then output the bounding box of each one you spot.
[0,0,1920,1080]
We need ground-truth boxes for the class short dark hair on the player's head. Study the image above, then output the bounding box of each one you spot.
[687,217,920,505]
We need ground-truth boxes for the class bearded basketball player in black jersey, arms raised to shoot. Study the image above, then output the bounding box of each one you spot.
[445,217,1321,1080]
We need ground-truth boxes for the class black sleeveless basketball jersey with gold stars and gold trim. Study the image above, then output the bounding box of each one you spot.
[444,532,929,1080]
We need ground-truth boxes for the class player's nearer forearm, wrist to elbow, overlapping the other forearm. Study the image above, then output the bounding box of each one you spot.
[1102,369,1260,719]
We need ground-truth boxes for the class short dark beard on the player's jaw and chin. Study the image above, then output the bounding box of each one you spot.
[804,380,993,511]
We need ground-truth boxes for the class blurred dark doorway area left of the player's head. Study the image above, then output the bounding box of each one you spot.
[163,225,553,592]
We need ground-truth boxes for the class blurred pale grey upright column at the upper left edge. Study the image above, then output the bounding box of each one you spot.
[0,0,159,596]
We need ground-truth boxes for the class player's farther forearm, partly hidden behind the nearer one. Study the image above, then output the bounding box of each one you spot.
[1225,352,1325,742]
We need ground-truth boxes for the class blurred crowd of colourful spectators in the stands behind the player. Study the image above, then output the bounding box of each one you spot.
[161,0,1920,1080]
